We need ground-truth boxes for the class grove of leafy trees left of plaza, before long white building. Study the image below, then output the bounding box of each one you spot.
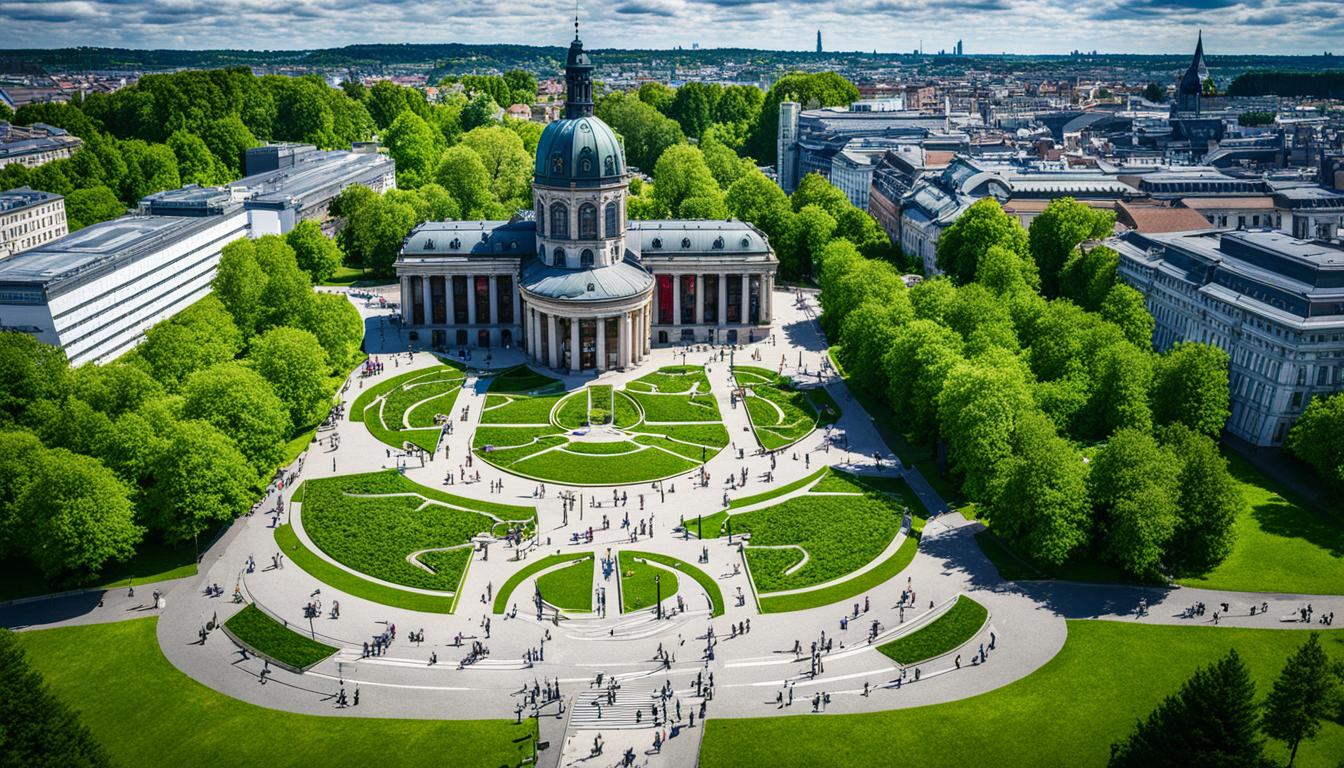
[0,227,363,584]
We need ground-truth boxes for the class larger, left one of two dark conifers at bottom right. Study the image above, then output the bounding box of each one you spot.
[1107,648,1267,768]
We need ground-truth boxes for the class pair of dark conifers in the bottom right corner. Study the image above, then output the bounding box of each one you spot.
[1109,632,1344,768]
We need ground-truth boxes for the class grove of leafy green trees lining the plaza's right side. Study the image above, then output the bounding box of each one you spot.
[820,199,1245,577]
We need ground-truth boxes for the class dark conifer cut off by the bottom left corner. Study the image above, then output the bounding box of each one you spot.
[0,632,113,768]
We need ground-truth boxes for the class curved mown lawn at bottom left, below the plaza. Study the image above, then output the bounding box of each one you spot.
[19,617,536,768]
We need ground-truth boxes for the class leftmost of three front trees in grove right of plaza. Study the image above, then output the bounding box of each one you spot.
[984,410,1091,568]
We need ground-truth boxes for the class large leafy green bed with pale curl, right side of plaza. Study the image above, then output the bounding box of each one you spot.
[732,492,902,592]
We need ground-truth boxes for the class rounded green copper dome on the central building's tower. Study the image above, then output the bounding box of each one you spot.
[534,117,625,187]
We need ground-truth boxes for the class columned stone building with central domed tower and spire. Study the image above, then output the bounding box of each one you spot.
[396,26,778,373]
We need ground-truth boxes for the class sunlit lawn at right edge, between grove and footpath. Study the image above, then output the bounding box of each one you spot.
[1177,451,1344,594]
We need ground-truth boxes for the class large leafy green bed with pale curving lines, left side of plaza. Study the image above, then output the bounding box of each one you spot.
[302,472,535,592]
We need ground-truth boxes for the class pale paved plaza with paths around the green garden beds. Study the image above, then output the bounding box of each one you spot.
[0,288,1344,765]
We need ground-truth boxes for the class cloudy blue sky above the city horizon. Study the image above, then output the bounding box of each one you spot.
[0,0,1344,55]
